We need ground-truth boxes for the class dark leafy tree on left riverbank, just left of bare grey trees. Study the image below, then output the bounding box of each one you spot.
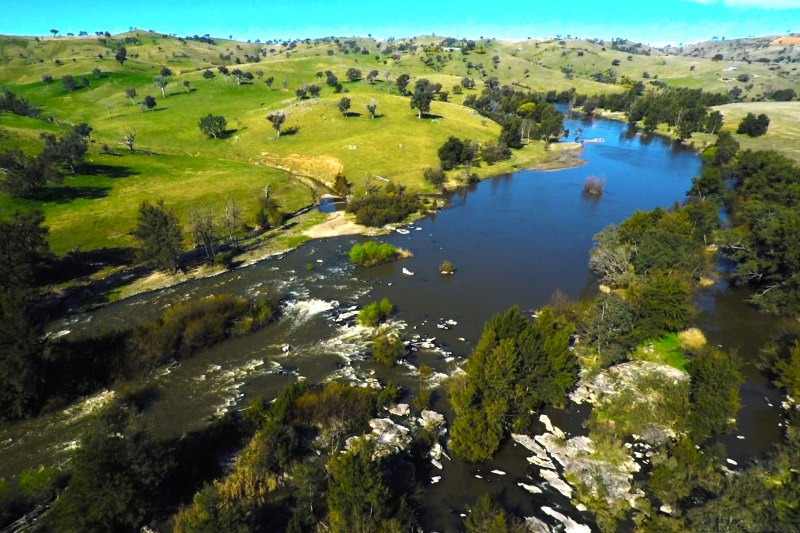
[133,200,183,272]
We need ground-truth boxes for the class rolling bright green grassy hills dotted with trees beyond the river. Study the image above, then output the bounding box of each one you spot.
[0,30,800,252]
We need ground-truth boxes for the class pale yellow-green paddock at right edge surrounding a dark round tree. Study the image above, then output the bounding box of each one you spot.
[716,102,800,161]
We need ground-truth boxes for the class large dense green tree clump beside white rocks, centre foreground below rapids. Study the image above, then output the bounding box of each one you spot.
[449,307,578,462]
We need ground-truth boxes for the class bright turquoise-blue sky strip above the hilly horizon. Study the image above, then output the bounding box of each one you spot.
[0,0,800,44]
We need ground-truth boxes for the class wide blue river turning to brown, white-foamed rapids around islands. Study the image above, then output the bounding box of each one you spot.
[0,111,779,530]
